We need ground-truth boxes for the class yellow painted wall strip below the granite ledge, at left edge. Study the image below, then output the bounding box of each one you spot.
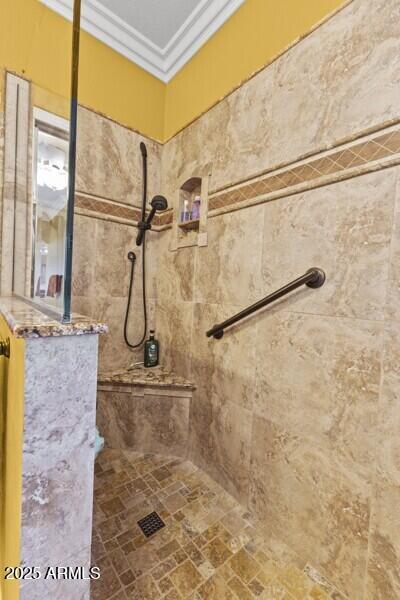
[0,317,25,600]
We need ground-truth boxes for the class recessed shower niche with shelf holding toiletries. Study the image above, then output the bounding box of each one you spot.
[174,175,209,248]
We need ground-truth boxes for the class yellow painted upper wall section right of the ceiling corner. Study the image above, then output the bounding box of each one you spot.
[164,0,345,139]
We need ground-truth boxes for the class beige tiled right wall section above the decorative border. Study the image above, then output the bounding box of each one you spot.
[163,0,399,197]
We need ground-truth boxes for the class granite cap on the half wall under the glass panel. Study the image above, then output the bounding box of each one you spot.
[0,296,108,338]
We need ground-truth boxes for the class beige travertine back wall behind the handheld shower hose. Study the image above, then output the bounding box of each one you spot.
[73,108,161,372]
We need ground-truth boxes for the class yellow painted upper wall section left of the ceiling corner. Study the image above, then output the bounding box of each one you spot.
[0,0,165,140]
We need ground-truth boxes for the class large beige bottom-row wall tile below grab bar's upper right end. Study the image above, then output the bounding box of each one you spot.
[250,417,370,597]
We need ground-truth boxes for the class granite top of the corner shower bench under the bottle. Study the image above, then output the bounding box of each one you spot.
[97,365,196,390]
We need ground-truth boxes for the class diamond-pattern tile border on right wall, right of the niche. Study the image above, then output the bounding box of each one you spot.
[209,125,400,217]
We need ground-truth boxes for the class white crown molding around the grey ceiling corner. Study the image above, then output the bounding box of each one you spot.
[40,0,245,83]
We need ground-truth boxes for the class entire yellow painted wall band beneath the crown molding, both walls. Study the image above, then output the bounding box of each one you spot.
[0,0,346,141]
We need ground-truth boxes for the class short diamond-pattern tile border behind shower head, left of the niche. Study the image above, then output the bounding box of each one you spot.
[75,192,172,230]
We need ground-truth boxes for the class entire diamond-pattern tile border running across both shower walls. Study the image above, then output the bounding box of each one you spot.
[75,124,400,231]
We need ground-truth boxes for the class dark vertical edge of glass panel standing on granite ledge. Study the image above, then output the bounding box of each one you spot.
[63,0,81,323]
